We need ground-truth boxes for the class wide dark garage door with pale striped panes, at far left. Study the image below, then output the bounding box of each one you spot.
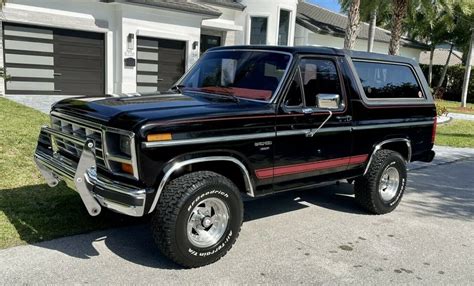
[3,23,105,95]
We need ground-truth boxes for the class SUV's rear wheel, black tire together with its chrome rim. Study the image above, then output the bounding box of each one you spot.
[354,150,407,214]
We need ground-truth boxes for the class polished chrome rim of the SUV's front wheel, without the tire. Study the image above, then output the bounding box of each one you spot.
[187,198,229,248]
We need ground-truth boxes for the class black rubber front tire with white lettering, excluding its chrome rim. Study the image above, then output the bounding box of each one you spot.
[151,171,243,268]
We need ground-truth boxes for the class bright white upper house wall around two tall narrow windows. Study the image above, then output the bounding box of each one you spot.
[235,0,298,46]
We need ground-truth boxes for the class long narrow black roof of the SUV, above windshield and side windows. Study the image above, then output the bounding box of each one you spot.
[208,45,418,66]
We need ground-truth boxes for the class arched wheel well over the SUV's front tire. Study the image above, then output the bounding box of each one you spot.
[170,161,250,193]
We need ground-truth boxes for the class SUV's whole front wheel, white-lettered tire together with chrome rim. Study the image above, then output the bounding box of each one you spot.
[151,171,243,268]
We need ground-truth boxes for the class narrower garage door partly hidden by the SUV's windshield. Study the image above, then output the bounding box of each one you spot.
[137,37,186,92]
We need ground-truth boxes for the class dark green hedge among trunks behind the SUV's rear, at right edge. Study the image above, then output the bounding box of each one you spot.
[420,65,474,103]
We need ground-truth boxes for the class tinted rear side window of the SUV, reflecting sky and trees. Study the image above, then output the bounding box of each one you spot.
[354,61,423,99]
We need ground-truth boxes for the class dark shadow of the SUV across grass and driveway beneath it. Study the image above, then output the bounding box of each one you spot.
[2,181,364,269]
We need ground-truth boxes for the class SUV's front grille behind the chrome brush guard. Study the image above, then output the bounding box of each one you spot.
[51,116,106,169]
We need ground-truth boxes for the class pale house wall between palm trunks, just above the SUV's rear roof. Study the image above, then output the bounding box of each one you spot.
[295,24,423,61]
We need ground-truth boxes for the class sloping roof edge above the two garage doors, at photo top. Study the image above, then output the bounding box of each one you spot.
[102,0,223,17]
